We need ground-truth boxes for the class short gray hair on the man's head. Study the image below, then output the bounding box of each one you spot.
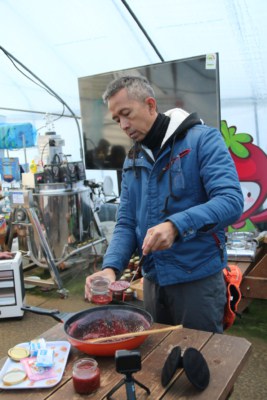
[102,75,155,103]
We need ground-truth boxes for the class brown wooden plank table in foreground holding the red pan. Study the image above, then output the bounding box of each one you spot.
[0,323,251,400]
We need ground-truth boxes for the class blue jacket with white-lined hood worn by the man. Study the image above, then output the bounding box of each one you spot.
[103,109,243,286]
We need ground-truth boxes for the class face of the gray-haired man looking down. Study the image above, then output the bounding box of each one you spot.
[108,89,157,142]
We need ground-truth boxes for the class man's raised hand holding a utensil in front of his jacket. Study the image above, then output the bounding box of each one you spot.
[142,221,178,255]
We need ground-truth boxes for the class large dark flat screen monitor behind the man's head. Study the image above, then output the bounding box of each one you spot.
[78,53,220,171]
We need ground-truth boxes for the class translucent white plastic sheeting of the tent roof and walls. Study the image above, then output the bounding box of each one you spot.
[0,0,267,159]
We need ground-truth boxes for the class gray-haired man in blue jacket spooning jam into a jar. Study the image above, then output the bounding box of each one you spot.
[85,76,243,333]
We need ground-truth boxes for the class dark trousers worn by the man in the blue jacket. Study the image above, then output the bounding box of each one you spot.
[144,271,226,333]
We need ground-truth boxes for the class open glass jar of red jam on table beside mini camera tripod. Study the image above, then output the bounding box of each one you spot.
[72,358,100,394]
